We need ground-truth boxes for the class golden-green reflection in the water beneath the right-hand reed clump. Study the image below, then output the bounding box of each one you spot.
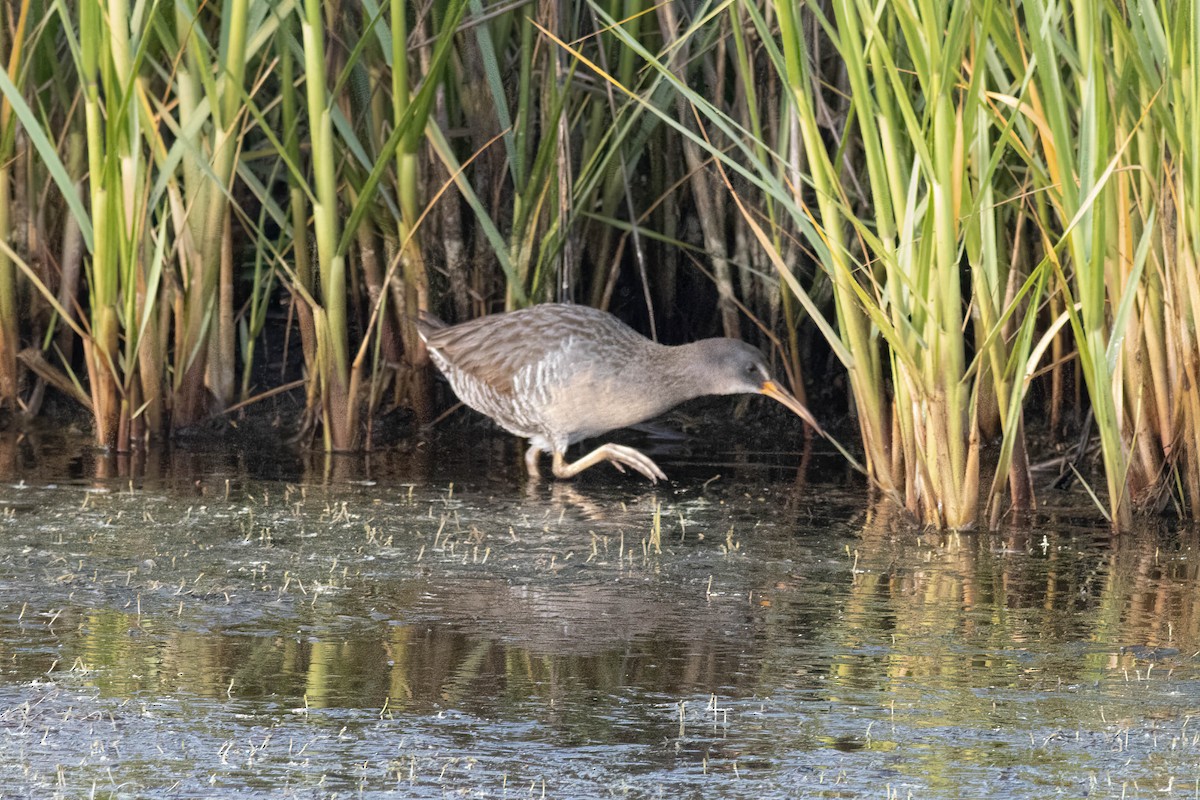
[836,521,1200,686]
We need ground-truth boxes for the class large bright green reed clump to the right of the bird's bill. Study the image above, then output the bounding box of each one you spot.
[544,1,1196,529]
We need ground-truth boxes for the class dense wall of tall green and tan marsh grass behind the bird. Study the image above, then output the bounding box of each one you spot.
[0,0,1200,529]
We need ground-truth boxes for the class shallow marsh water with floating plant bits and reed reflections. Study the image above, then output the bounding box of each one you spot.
[0,435,1200,798]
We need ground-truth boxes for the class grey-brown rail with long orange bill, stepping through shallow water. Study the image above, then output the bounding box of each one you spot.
[416,303,824,482]
